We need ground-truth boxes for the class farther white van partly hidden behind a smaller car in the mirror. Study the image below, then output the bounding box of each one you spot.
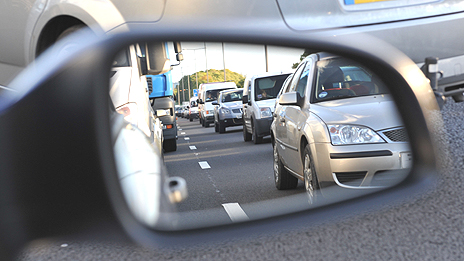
[198,82,237,127]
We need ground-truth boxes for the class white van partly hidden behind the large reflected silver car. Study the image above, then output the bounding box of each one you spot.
[242,72,291,144]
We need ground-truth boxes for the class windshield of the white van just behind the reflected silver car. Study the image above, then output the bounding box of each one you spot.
[255,74,289,101]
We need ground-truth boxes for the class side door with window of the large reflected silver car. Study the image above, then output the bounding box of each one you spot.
[285,59,313,175]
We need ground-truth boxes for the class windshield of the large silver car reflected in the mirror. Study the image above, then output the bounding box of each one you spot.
[313,58,388,102]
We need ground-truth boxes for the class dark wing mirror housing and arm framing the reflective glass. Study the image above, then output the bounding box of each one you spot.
[0,25,438,251]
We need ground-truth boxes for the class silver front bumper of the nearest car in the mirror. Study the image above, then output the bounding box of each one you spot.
[312,143,412,196]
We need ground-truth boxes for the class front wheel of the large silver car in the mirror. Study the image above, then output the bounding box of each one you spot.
[303,145,319,204]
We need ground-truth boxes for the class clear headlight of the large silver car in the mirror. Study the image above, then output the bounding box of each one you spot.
[327,125,385,145]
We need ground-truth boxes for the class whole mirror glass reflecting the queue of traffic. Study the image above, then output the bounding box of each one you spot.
[109,42,412,230]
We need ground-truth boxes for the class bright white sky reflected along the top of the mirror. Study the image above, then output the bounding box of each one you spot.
[169,42,304,83]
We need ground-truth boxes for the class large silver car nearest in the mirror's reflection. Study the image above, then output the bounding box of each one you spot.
[271,53,411,199]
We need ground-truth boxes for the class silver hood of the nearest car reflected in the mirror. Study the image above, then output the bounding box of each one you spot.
[310,95,403,130]
